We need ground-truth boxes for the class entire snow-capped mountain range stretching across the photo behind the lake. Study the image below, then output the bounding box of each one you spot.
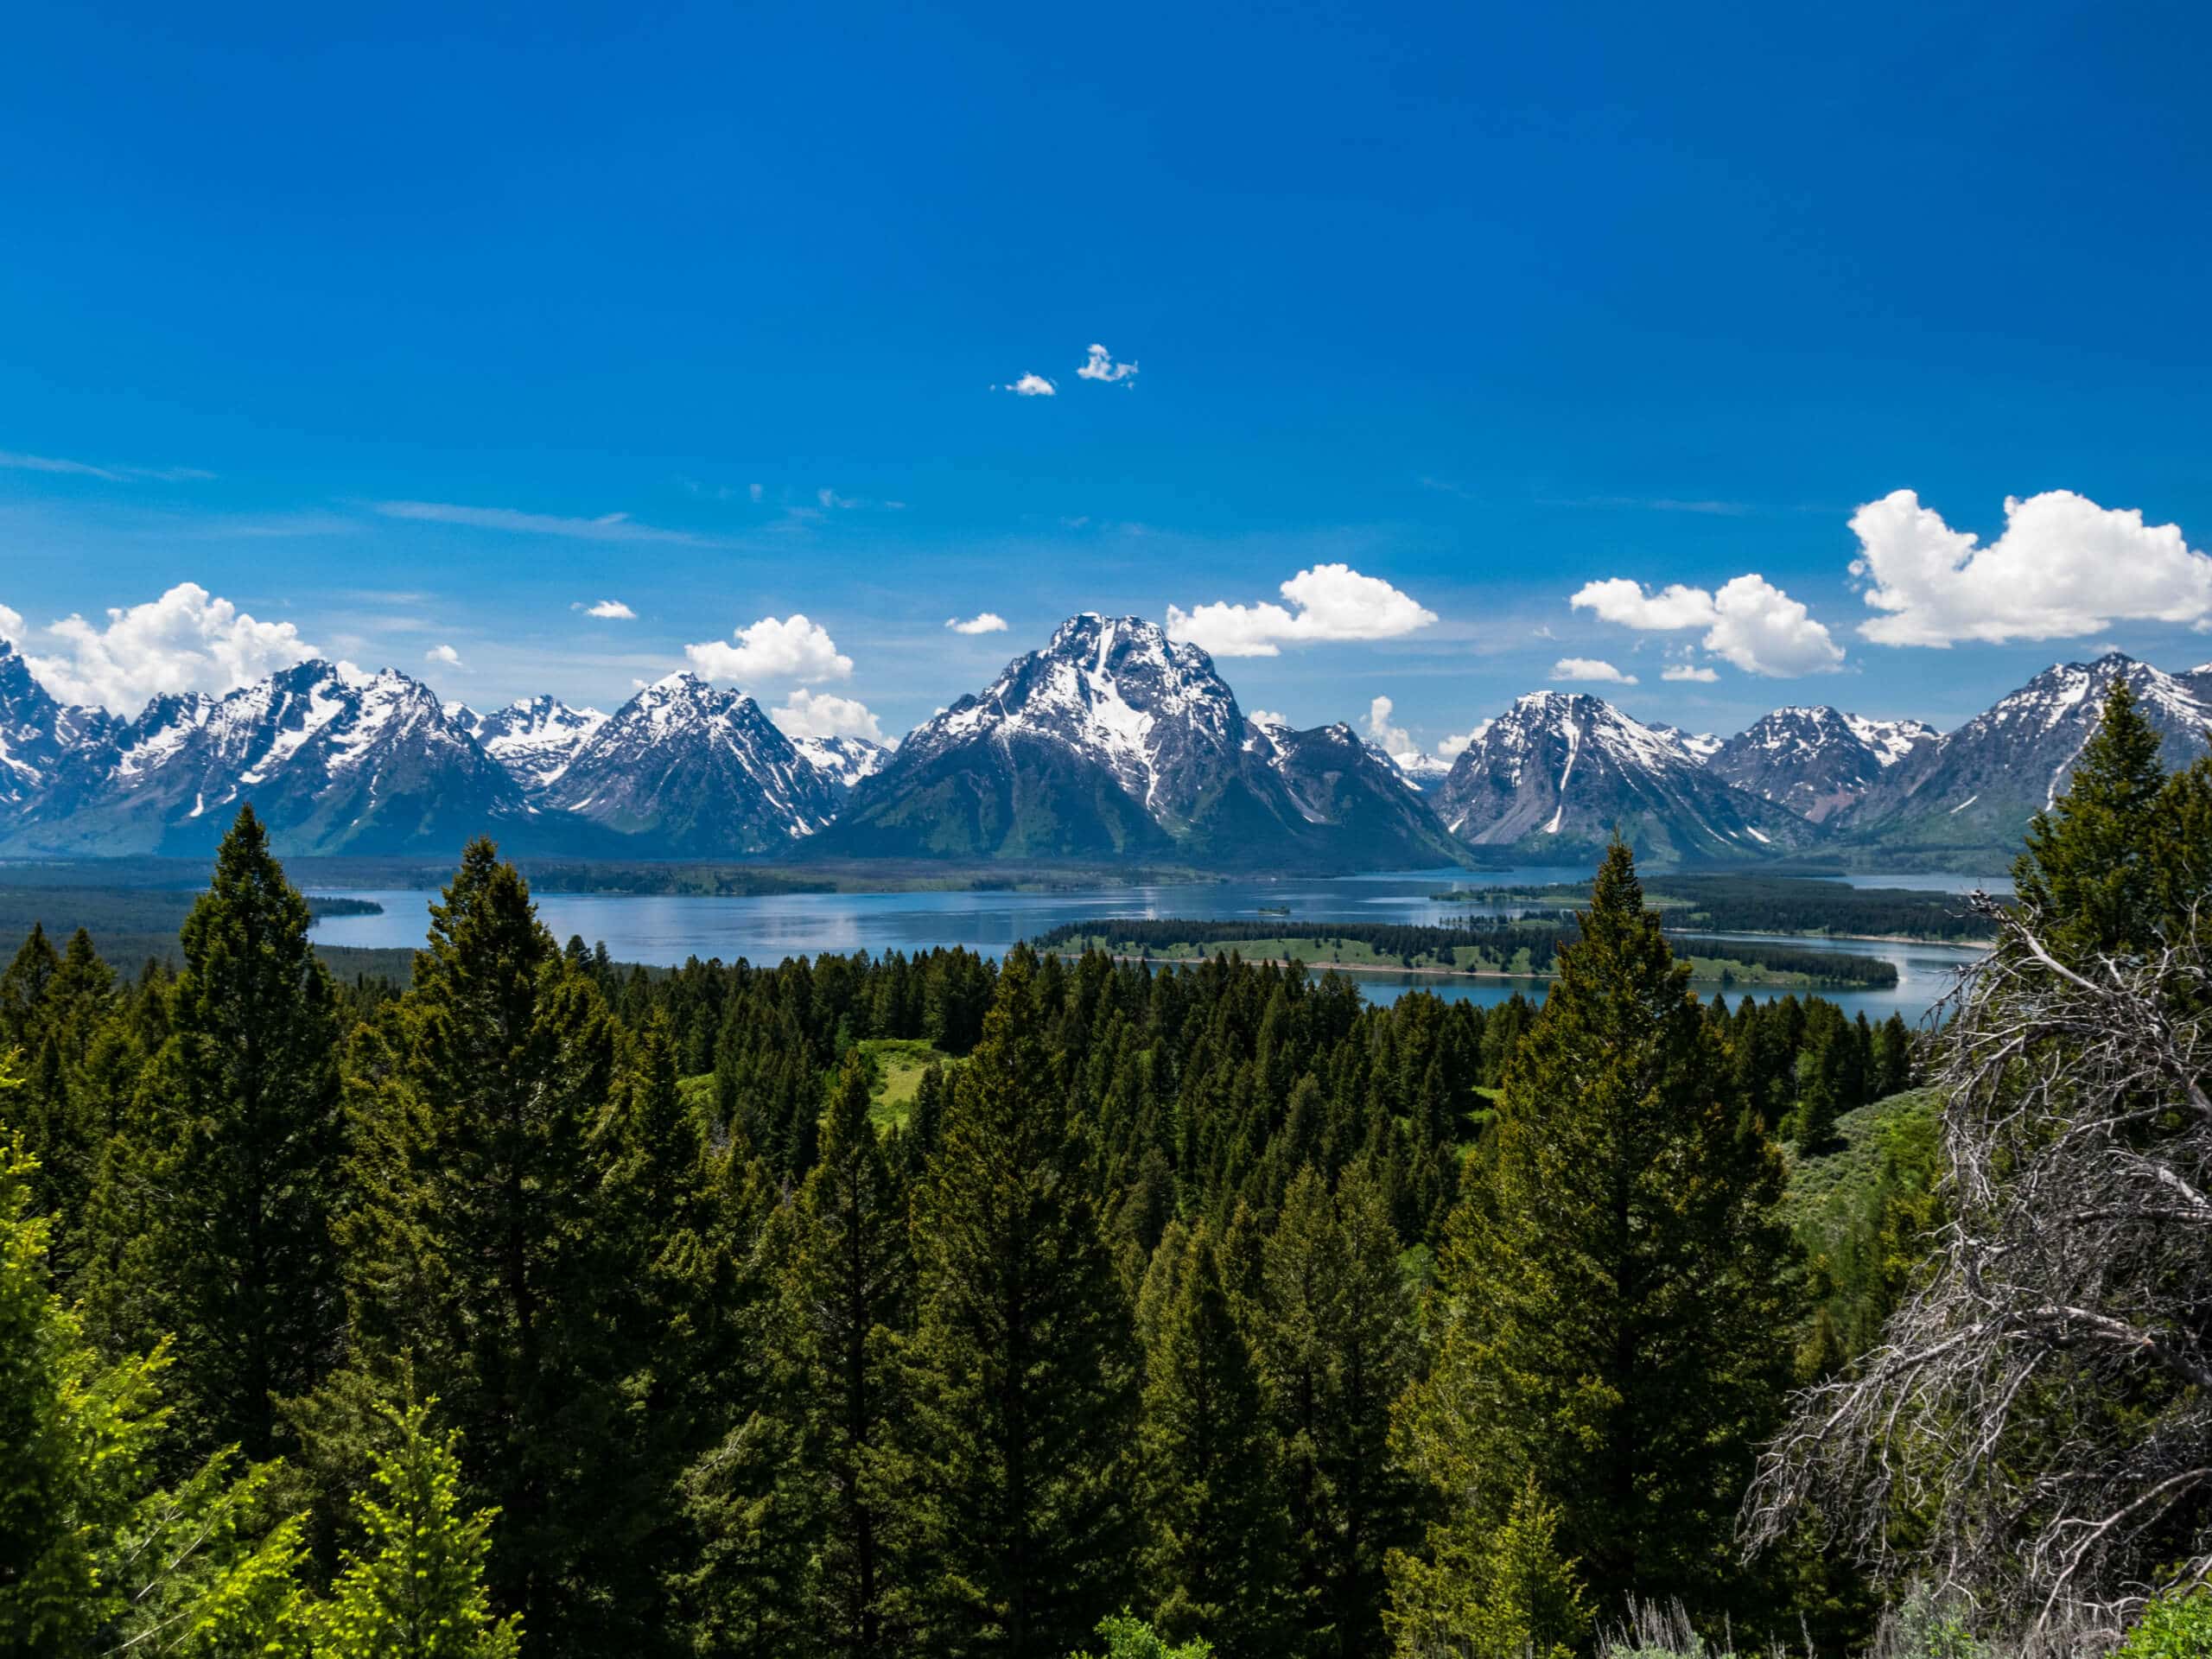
[0,613,2212,872]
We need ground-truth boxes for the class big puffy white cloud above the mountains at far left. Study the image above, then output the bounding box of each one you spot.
[29,582,315,715]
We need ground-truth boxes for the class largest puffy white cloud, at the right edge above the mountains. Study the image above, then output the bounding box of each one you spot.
[1852,489,2212,646]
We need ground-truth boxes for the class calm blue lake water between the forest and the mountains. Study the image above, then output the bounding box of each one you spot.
[315,865,1988,1022]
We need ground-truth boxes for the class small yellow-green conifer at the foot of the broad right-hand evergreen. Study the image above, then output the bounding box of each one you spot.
[1382,1482,1591,1659]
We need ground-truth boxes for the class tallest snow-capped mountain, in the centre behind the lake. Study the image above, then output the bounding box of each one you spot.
[821,613,1449,868]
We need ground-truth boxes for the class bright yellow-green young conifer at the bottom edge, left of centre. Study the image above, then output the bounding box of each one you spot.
[308,1400,522,1659]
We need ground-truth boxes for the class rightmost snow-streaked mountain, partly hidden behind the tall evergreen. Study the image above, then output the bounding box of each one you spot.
[1849,651,2212,856]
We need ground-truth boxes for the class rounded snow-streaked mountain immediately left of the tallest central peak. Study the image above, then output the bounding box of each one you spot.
[542,672,842,856]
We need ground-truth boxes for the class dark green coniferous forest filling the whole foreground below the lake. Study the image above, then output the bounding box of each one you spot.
[0,681,2212,1659]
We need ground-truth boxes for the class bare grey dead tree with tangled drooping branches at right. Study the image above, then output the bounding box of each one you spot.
[1743,898,2212,1630]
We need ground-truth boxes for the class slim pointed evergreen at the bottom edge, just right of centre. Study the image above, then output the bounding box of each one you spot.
[1141,1225,1289,1656]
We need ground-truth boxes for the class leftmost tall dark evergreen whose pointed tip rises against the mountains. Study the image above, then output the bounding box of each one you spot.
[142,807,345,1458]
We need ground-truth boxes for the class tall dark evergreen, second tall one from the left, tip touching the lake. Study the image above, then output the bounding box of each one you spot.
[347,841,623,1652]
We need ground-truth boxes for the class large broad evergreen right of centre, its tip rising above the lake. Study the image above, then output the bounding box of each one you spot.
[1394,845,1794,1611]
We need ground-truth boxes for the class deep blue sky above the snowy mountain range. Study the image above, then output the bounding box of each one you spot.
[0,0,2212,746]
